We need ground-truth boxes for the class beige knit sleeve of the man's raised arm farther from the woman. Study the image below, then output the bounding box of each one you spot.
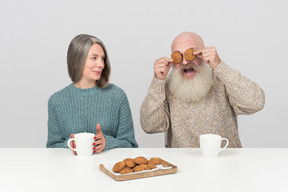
[214,61,265,115]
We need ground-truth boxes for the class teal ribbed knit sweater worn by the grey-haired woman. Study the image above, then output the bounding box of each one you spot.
[46,83,138,150]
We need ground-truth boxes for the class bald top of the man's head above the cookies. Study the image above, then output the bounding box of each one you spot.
[171,32,204,52]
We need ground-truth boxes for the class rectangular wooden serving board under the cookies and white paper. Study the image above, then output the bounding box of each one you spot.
[99,159,177,181]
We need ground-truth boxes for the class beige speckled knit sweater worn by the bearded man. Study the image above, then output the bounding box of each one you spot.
[140,61,265,147]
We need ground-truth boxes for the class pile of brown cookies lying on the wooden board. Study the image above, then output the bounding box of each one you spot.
[113,156,161,174]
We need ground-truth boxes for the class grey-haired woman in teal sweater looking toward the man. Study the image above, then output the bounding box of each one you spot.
[46,34,138,153]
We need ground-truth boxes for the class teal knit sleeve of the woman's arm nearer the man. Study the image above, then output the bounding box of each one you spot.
[104,94,138,150]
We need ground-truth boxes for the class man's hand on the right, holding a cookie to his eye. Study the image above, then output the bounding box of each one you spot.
[193,47,221,69]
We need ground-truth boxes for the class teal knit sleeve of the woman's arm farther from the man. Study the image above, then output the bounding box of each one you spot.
[46,98,69,148]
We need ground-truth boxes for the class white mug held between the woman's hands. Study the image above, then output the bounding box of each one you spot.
[67,132,95,156]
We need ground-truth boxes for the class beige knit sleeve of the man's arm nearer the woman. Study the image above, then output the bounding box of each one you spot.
[140,77,170,133]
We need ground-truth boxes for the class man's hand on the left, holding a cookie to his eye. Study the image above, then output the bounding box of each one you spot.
[154,57,173,80]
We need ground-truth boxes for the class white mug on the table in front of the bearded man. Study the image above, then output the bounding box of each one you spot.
[200,134,229,157]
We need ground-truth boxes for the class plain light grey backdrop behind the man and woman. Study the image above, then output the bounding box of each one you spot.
[0,0,288,148]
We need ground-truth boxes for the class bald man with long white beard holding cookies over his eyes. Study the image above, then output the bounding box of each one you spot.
[140,32,265,147]
